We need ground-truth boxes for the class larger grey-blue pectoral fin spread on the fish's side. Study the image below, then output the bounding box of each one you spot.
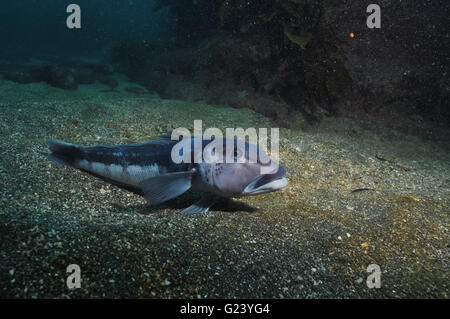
[139,170,196,205]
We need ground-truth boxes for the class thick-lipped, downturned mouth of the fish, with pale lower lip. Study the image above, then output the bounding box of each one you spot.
[243,166,288,195]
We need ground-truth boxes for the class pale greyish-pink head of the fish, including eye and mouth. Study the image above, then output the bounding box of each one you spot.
[201,140,288,197]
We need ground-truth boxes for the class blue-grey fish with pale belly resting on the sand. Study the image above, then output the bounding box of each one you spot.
[49,134,288,214]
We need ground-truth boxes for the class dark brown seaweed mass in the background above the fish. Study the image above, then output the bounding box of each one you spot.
[146,0,353,122]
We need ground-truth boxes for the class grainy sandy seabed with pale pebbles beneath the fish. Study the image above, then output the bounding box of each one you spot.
[0,81,450,298]
